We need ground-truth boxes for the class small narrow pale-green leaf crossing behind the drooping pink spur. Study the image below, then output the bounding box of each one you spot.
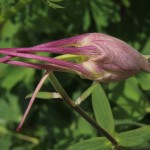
[25,92,61,99]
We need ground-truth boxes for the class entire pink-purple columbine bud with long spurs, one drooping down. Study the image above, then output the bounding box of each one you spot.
[0,33,150,129]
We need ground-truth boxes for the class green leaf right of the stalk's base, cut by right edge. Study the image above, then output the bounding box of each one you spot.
[118,126,150,147]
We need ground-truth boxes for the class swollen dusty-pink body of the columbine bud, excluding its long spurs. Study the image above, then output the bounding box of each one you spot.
[75,33,150,83]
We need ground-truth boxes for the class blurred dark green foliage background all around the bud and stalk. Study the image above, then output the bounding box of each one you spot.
[0,0,150,150]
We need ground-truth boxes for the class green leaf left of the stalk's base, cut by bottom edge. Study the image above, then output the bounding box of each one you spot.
[67,137,112,150]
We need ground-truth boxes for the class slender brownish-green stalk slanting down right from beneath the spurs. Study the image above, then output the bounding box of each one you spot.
[49,72,119,149]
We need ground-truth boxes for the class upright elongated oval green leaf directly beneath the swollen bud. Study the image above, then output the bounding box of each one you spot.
[92,84,115,134]
